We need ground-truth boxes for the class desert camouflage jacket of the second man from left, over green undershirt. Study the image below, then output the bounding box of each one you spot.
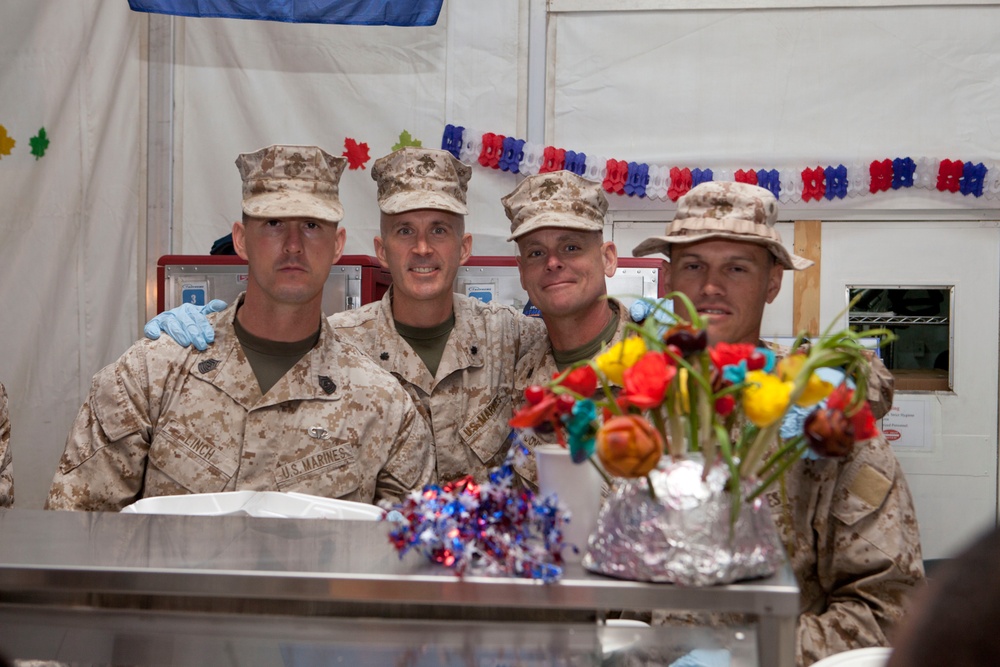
[330,291,547,482]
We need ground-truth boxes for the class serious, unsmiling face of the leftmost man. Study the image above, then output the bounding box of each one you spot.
[233,216,346,305]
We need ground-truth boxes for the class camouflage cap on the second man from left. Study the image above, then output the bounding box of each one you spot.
[372,146,472,215]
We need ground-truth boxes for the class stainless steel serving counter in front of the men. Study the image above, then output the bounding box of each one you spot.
[0,510,798,667]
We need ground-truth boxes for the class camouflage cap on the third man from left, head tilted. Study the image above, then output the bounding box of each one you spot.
[500,171,608,241]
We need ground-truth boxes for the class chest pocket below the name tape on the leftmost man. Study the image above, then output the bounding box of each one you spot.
[149,420,238,493]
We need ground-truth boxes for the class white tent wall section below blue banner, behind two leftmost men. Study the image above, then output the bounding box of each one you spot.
[174,2,520,262]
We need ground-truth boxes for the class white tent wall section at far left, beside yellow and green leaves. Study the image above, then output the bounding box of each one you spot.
[0,0,142,507]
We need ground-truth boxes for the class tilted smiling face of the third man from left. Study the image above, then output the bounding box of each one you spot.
[517,227,618,322]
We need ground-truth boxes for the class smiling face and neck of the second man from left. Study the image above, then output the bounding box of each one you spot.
[375,209,472,324]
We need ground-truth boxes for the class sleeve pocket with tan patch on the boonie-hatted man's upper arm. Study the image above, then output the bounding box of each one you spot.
[831,439,899,526]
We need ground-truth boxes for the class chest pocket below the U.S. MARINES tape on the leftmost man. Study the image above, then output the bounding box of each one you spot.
[275,442,361,500]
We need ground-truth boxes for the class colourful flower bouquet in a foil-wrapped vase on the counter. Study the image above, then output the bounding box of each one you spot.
[511,293,888,585]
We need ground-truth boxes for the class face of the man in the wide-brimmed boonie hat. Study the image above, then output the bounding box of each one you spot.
[663,240,783,345]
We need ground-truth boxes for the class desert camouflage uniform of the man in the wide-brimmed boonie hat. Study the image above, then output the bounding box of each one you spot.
[767,347,924,665]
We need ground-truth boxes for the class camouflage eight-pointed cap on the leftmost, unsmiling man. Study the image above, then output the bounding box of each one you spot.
[236,146,347,222]
